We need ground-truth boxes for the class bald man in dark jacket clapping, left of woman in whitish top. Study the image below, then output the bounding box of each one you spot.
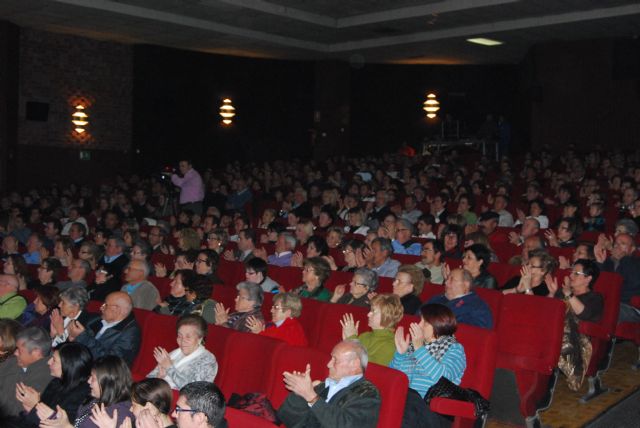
[68,291,140,366]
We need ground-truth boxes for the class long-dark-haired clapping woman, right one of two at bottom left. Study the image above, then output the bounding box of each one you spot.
[35,355,134,428]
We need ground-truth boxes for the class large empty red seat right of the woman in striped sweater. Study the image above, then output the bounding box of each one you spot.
[496,294,565,421]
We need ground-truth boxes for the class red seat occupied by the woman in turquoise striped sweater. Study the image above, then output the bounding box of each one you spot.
[431,324,498,427]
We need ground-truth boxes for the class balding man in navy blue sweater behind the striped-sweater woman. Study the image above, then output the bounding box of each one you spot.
[428,269,493,328]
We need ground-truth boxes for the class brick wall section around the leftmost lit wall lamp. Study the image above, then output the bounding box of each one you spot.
[18,28,133,151]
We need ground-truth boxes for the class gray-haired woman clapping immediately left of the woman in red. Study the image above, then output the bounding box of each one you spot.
[215,281,264,333]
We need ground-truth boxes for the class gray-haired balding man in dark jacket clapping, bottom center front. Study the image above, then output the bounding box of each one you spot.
[278,340,380,428]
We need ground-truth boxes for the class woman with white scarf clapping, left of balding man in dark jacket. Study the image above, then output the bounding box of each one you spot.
[50,287,99,346]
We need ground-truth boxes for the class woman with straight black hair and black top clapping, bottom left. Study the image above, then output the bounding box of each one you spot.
[11,343,93,428]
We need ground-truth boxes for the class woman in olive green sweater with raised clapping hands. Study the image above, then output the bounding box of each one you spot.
[340,294,404,366]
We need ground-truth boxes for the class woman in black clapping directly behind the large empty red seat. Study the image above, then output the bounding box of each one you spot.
[502,250,558,297]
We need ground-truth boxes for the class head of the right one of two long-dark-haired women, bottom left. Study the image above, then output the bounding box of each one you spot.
[93,355,132,406]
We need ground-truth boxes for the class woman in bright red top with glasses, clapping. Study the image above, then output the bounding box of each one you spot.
[247,293,309,346]
